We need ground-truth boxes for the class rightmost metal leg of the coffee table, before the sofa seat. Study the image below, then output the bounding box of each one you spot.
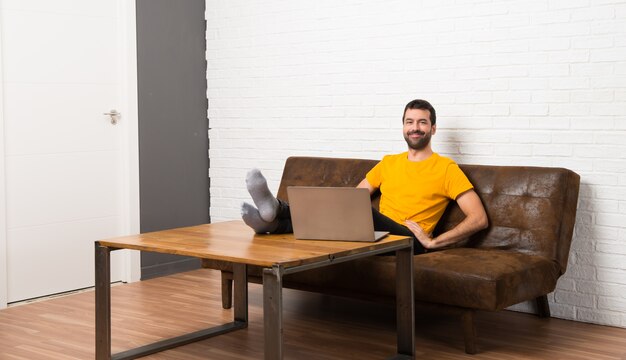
[396,248,415,358]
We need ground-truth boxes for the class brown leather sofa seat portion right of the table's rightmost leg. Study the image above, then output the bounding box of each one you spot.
[414,248,559,310]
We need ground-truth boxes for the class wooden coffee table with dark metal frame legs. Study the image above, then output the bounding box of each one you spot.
[95,221,415,360]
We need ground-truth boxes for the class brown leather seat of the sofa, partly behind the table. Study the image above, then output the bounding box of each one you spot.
[204,248,559,310]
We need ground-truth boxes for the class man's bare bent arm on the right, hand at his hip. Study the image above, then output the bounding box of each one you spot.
[406,190,489,249]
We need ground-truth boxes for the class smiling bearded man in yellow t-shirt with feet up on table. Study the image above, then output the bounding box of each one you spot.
[241,99,488,254]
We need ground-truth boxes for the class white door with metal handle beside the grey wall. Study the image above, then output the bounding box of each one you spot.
[0,0,139,307]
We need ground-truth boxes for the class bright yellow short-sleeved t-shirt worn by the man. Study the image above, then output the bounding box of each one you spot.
[366,152,474,233]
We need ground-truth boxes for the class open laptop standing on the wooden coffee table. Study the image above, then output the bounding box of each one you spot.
[287,186,389,242]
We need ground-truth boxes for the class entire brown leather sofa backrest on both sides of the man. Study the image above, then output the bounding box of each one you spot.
[278,157,580,273]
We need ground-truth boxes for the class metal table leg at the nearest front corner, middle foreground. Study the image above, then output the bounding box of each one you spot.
[263,266,283,360]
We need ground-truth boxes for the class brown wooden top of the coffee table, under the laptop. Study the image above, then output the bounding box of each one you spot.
[97,220,411,268]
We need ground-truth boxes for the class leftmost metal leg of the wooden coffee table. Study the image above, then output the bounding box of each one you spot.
[95,242,111,360]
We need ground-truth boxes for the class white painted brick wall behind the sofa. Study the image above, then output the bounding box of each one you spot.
[207,0,626,327]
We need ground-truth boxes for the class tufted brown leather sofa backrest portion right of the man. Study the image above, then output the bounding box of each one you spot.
[437,164,580,274]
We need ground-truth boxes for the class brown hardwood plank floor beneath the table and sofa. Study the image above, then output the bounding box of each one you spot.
[0,269,626,360]
